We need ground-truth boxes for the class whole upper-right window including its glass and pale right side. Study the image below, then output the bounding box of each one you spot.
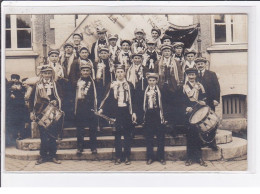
[212,14,247,44]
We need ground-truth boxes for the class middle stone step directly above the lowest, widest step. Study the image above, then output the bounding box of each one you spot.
[16,130,232,150]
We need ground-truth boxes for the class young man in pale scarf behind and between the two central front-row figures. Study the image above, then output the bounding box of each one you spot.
[126,52,148,124]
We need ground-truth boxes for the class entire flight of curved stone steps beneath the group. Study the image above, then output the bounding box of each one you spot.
[6,127,247,161]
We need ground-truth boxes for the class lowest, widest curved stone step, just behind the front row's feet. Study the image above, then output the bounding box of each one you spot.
[5,137,247,161]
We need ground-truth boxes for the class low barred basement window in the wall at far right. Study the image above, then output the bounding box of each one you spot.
[222,95,246,119]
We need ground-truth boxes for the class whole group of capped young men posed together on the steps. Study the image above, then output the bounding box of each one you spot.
[6,28,220,166]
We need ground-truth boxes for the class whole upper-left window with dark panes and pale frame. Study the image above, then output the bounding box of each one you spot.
[5,15,32,50]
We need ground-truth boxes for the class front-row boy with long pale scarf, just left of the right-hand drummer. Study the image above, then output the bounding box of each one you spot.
[143,72,166,165]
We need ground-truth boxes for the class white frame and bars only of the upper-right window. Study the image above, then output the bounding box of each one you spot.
[211,14,248,45]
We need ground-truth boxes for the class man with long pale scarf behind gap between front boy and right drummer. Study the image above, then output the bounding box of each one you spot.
[155,45,183,126]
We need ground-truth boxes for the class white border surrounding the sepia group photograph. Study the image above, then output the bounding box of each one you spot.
[1,1,260,186]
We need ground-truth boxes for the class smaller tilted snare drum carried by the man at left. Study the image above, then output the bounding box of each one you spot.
[37,104,64,129]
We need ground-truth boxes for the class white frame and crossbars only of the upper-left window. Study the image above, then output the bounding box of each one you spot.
[5,14,33,51]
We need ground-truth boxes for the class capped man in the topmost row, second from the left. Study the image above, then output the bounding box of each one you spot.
[89,27,108,63]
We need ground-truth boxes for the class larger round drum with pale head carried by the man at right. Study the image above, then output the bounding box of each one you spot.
[189,105,219,143]
